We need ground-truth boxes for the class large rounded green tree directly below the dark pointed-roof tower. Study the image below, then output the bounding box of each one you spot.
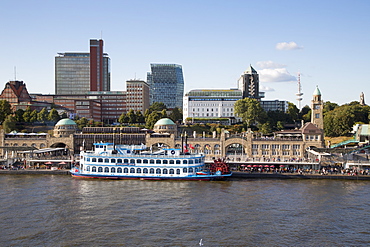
[234,98,266,127]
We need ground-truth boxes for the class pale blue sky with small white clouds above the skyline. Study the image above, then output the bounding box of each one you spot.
[0,0,370,107]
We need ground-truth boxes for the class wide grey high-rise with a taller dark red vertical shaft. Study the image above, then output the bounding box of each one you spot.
[55,40,110,95]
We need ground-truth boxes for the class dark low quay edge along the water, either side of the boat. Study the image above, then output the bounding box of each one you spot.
[0,169,370,181]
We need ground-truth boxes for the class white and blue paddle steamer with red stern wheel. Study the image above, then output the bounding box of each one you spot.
[70,143,231,180]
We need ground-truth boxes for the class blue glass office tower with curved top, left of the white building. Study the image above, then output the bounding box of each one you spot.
[147,64,184,109]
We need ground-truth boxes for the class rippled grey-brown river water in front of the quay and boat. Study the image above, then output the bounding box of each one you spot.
[0,175,370,246]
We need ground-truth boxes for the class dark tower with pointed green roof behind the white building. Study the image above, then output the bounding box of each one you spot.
[238,65,261,100]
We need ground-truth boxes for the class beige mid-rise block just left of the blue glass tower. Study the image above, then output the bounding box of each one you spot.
[126,80,150,114]
